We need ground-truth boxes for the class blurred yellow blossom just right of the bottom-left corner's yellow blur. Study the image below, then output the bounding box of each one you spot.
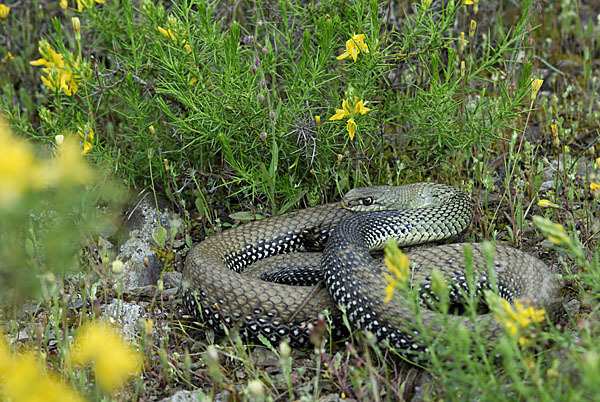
[70,322,142,392]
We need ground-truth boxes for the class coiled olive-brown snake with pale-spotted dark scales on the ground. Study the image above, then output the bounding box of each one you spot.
[182,183,562,352]
